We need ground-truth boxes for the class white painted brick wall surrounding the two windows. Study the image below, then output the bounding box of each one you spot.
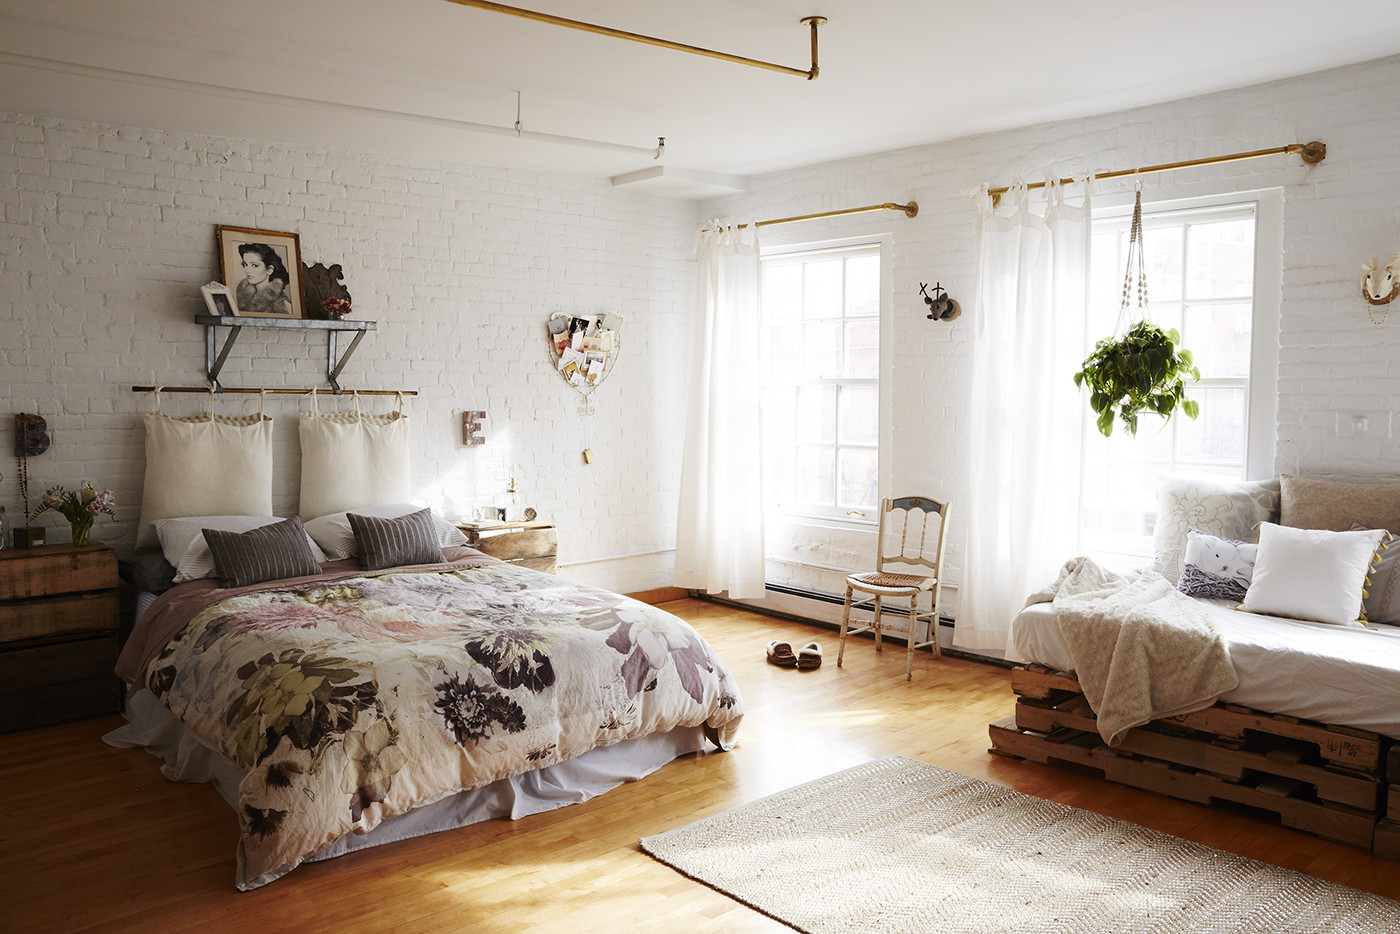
[700,51,1400,621]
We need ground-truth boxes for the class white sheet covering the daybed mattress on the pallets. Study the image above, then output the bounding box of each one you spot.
[1007,599,1400,739]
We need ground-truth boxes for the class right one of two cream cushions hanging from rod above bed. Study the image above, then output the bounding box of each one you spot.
[300,393,413,520]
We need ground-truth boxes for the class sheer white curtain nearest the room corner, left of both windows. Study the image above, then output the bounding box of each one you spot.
[676,224,764,598]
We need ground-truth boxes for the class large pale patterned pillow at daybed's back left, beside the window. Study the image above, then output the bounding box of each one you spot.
[1152,478,1278,584]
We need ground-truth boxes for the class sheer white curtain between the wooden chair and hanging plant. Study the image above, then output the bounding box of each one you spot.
[953,182,1089,650]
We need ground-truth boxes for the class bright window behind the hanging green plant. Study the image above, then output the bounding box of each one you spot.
[1079,193,1281,566]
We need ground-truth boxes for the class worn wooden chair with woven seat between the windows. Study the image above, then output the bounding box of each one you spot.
[836,496,948,681]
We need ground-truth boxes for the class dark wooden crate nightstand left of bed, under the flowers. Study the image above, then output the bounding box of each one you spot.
[0,543,122,732]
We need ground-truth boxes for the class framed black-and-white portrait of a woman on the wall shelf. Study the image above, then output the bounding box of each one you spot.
[214,224,307,318]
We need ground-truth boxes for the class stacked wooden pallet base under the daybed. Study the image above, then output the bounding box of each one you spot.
[990,667,1400,856]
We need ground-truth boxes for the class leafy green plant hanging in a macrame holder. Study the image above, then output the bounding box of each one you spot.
[1074,190,1201,437]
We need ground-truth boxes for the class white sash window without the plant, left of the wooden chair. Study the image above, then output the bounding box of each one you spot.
[763,245,881,521]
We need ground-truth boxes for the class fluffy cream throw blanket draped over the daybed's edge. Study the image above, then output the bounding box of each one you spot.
[1026,557,1239,746]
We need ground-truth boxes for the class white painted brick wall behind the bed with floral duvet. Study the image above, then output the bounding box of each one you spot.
[0,115,694,591]
